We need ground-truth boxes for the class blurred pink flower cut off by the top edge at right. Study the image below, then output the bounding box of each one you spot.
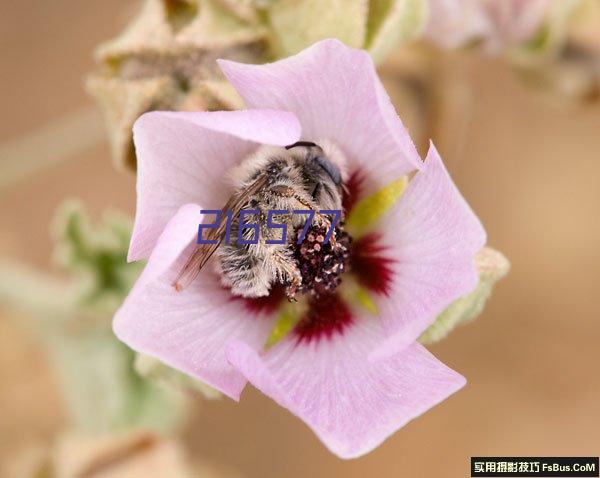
[425,0,552,53]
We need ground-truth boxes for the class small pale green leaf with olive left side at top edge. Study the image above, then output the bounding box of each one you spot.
[365,0,428,63]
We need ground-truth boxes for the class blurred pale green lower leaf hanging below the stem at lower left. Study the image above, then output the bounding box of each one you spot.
[50,328,184,434]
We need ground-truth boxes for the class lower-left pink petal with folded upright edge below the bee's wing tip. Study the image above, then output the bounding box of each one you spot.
[113,204,272,400]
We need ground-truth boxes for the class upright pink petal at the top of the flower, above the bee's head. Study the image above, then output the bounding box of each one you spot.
[219,40,421,191]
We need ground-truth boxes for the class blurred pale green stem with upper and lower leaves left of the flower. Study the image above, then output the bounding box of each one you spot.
[0,203,191,434]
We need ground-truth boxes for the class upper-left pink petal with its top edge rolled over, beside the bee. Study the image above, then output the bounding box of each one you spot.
[128,110,300,261]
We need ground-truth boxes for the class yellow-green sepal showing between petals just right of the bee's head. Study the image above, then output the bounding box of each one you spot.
[346,176,408,235]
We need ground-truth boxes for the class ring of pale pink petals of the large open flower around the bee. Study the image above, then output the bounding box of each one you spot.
[114,40,485,458]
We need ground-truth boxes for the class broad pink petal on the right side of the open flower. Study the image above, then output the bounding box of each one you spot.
[372,144,486,358]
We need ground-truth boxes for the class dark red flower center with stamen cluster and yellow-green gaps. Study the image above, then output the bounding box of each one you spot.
[245,167,402,346]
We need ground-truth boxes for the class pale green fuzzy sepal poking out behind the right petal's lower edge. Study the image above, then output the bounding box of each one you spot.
[419,247,510,344]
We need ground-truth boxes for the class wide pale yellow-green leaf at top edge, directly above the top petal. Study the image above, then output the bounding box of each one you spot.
[267,0,369,56]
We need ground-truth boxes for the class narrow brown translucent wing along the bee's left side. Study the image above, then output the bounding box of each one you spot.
[173,175,267,292]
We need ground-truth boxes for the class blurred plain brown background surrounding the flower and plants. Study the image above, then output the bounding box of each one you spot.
[0,0,600,478]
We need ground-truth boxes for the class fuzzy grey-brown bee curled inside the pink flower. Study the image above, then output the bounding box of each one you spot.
[173,141,345,300]
